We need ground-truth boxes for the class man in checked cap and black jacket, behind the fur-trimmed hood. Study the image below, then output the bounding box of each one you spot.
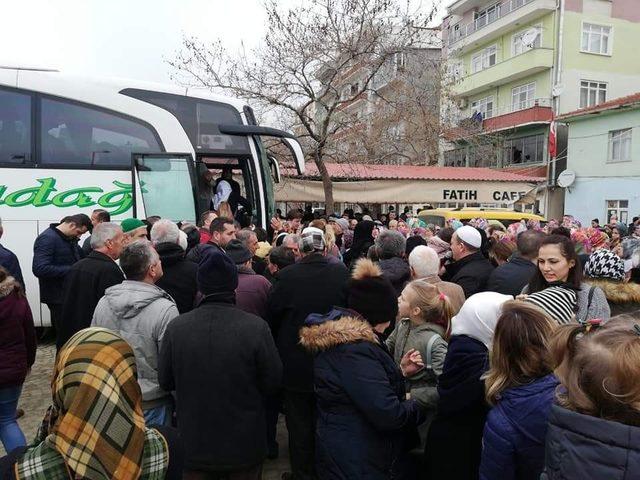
[268,228,349,480]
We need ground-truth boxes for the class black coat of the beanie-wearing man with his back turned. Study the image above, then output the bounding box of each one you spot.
[158,298,282,471]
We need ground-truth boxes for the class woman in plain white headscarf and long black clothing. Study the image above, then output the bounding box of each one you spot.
[423,292,513,480]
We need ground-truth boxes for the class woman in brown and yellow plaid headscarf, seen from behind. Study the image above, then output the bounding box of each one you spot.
[0,328,182,480]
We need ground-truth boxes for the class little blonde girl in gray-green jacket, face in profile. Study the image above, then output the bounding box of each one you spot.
[386,280,453,444]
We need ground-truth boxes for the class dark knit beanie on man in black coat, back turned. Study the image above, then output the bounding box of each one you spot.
[197,245,238,295]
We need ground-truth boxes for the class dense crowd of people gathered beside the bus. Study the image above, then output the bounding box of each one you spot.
[0,201,640,480]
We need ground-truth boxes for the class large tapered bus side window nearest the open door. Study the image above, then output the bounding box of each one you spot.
[40,98,164,167]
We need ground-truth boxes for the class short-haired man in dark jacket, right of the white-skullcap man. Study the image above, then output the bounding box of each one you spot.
[487,230,544,297]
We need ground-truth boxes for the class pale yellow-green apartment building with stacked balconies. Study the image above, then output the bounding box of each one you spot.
[441,0,640,217]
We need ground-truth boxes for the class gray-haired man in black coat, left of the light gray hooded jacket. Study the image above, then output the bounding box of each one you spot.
[56,222,124,349]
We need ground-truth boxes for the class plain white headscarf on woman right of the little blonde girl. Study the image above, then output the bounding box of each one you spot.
[451,292,513,349]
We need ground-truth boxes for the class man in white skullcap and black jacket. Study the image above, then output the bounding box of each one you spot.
[442,225,493,298]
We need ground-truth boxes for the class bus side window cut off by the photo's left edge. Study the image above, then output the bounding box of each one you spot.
[0,90,31,165]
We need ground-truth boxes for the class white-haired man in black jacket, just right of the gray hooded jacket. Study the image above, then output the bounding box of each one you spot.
[151,219,198,314]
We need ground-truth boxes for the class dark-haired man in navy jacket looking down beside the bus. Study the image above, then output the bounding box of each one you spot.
[31,213,91,338]
